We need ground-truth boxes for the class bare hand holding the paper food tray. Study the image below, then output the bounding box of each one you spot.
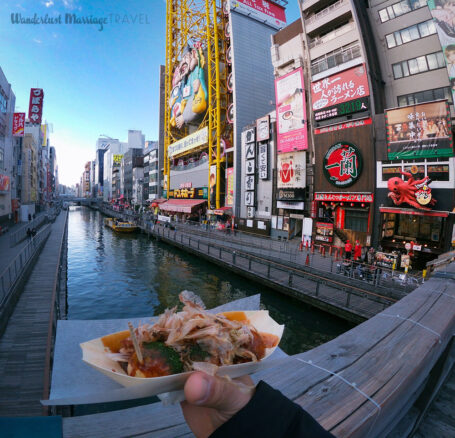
[181,371,254,438]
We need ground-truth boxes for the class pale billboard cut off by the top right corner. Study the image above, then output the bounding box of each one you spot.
[427,0,455,101]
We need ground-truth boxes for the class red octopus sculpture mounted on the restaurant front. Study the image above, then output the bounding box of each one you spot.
[387,171,436,210]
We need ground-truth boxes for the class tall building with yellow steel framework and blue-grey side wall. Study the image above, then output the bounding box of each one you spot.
[164,0,286,220]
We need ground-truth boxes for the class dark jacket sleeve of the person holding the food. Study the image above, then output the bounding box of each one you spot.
[209,381,334,438]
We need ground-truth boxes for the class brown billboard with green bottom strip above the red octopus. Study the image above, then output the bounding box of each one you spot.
[385,100,453,160]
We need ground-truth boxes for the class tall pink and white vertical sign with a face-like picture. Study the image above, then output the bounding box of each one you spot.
[275,67,308,153]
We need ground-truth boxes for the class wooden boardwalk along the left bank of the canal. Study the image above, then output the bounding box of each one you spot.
[0,212,67,417]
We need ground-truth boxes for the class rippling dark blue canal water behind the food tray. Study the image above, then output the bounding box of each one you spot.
[68,207,352,354]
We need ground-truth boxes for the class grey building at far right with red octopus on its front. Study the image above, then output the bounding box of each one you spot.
[368,0,455,268]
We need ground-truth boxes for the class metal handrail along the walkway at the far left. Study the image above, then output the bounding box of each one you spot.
[0,224,51,310]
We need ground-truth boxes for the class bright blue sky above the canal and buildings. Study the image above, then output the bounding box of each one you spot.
[0,0,299,185]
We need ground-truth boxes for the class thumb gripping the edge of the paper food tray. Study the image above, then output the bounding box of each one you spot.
[185,371,255,415]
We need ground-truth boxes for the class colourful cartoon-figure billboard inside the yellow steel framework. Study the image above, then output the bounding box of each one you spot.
[169,43,208,129]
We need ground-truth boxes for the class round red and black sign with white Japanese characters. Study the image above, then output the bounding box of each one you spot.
[323,141,363,187]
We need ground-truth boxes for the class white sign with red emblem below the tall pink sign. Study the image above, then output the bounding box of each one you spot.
[277,152,306,201]
